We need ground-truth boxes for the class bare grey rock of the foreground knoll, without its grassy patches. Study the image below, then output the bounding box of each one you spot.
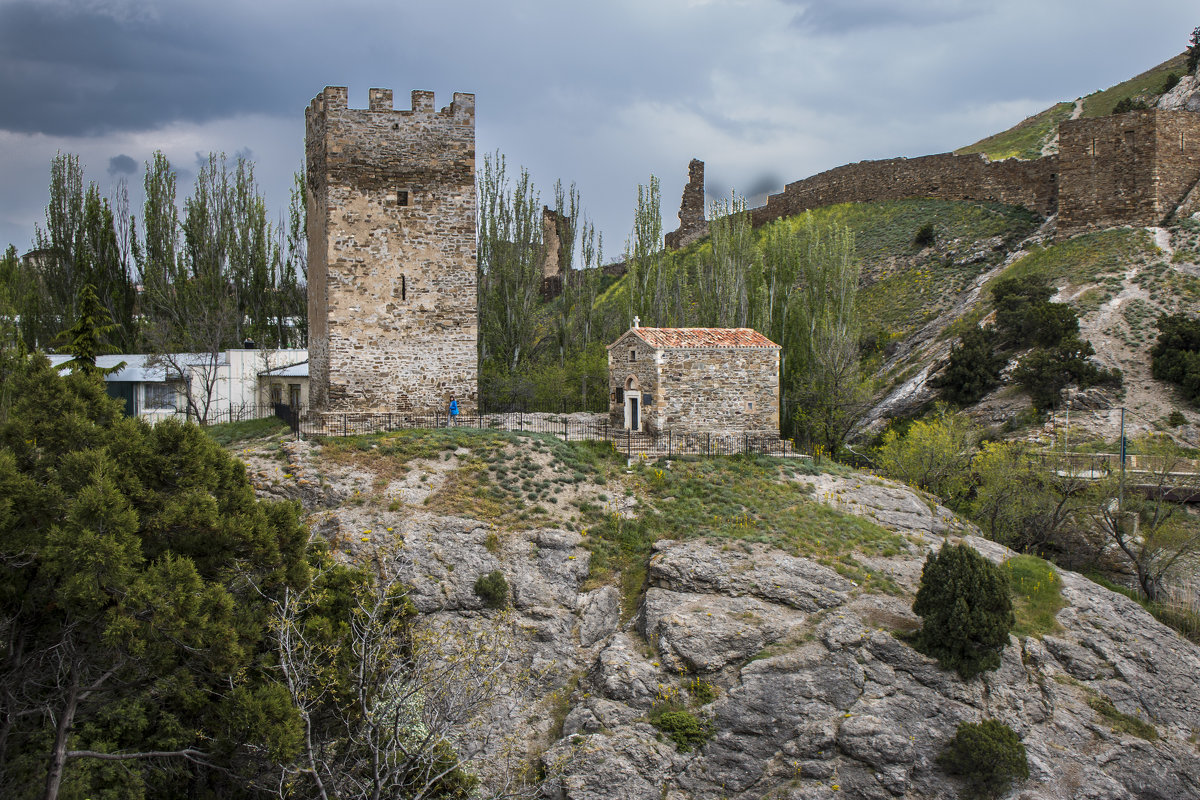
[243,438,1200,800]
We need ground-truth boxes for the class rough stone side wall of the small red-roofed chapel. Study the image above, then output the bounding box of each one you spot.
[655,348,779,435]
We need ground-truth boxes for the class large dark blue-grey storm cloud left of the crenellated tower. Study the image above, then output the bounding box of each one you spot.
[0,0,288,136]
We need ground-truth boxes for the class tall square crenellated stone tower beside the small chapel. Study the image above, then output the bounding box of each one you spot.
[305,86,479,413]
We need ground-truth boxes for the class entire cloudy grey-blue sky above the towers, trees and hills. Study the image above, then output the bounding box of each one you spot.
[0,0,1200,257]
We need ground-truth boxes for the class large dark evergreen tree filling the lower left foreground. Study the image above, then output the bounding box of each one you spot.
[0,357,308,800]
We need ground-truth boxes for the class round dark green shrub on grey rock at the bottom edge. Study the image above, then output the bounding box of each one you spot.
[937,720,1030,798]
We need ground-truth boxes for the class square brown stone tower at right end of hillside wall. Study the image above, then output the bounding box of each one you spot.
[1058,109,1200,236]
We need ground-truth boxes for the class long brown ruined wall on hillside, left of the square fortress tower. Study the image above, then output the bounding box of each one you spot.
[750,152,1058,227]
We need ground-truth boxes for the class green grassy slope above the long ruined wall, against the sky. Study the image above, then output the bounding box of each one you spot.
[954,53,1187,161]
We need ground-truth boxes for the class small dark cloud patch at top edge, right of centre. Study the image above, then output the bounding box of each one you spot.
[785,0,989,34]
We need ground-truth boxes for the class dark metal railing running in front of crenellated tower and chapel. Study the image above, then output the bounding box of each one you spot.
[286,411,804,458]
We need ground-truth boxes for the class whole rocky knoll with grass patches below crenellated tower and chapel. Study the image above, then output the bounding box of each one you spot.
[223,419,1200,800]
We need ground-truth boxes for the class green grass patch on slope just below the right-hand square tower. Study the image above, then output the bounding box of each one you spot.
[997,228,1158,292]
